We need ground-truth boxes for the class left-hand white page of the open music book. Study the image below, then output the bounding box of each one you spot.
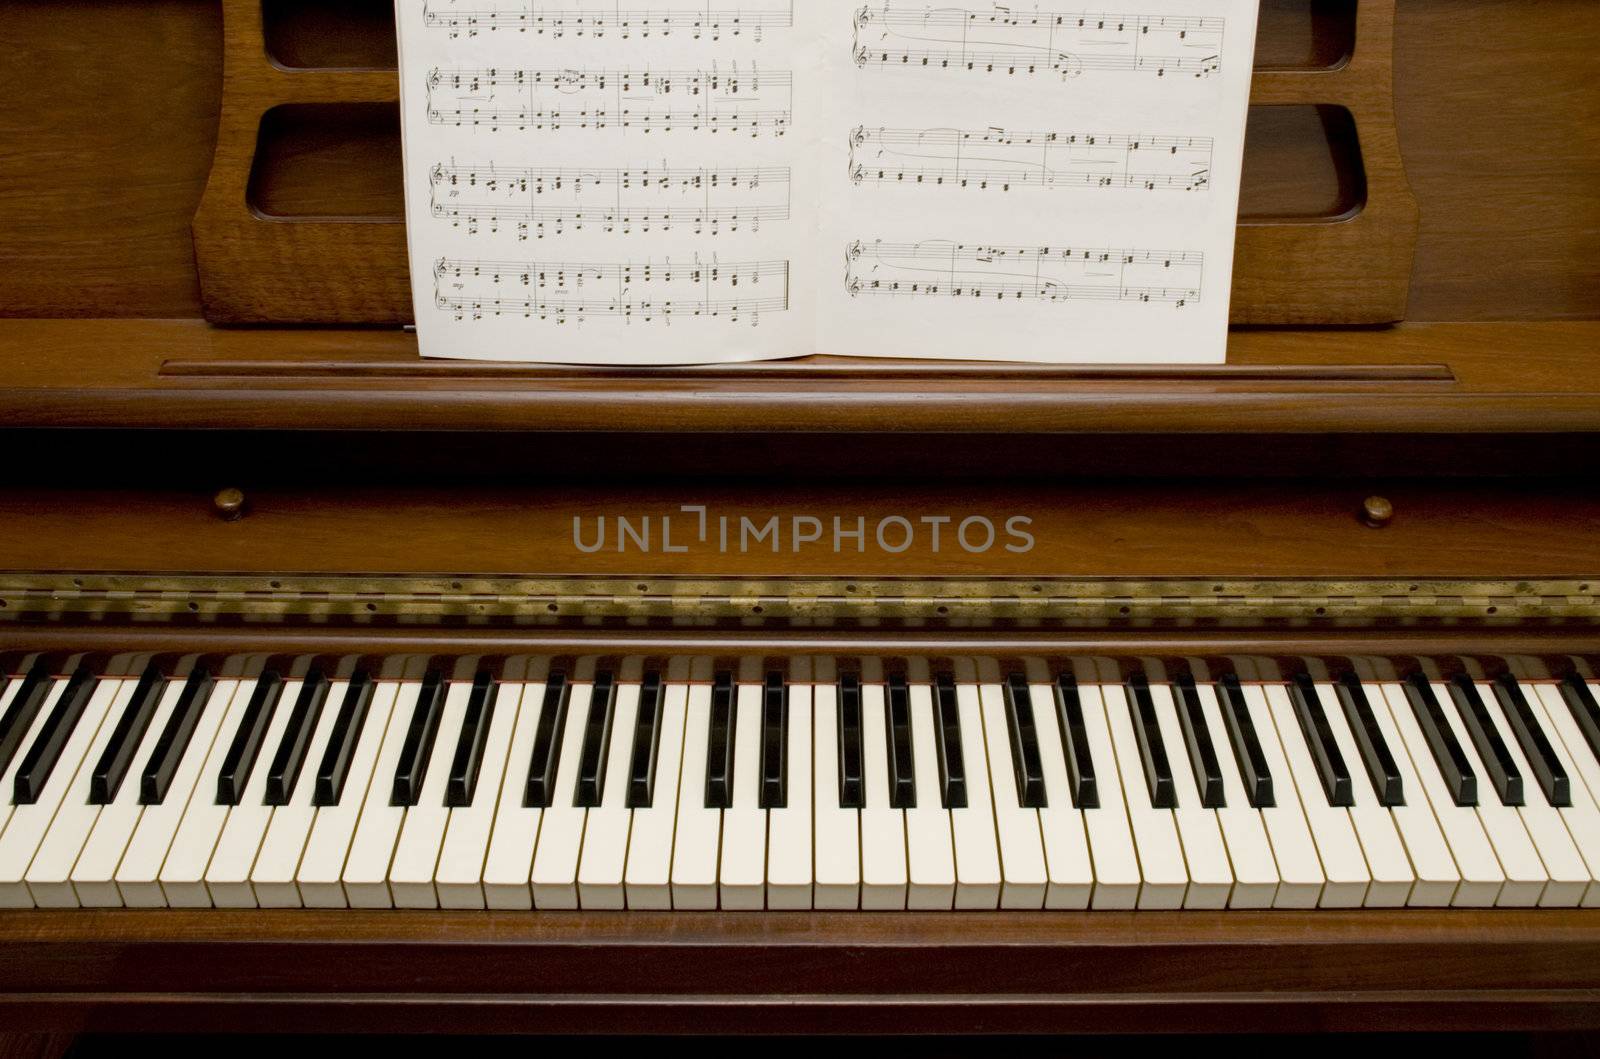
[397,0,822,365]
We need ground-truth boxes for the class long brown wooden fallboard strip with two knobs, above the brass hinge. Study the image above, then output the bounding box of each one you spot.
[0,480,1600,581]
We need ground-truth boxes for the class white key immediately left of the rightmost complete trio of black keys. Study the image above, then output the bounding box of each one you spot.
[1368,683,1506,909]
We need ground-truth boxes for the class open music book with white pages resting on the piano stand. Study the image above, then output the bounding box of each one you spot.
[397,0,1256,365]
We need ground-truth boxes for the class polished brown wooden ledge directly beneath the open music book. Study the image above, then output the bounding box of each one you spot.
[0,320,1600,435]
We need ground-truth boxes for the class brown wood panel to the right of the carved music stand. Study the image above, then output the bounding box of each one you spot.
[1395,0,1600,320]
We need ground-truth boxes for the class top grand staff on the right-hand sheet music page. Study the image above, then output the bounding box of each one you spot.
[853,0,1226,78]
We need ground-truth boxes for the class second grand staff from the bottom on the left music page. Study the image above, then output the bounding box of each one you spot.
[430,163,790,240]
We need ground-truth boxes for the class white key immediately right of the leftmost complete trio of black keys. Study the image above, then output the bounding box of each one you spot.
[296,681,405,909]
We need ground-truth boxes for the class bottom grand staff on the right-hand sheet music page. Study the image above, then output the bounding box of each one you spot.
[845,240,1205,309]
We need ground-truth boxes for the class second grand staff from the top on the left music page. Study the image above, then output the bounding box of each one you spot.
[427,66,794,136]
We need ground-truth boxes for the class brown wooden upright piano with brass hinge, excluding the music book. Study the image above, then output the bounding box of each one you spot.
[0,0,1600,1049]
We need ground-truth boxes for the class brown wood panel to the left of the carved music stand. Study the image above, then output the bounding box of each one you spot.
[0,0,222,317]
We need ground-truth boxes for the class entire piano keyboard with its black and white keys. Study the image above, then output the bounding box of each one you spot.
[0,656,1600,910]
